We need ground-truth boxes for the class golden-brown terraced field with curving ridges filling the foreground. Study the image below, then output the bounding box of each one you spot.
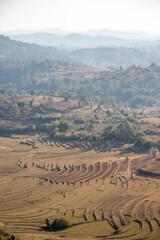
[0,136,160,240]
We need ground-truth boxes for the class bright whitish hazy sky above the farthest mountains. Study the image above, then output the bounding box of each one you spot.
[0,0,160,32]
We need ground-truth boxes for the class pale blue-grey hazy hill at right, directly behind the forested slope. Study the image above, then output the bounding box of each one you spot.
[70,46,160,68]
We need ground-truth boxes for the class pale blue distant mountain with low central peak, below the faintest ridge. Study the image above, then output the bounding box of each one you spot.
[10,33,135,48]
